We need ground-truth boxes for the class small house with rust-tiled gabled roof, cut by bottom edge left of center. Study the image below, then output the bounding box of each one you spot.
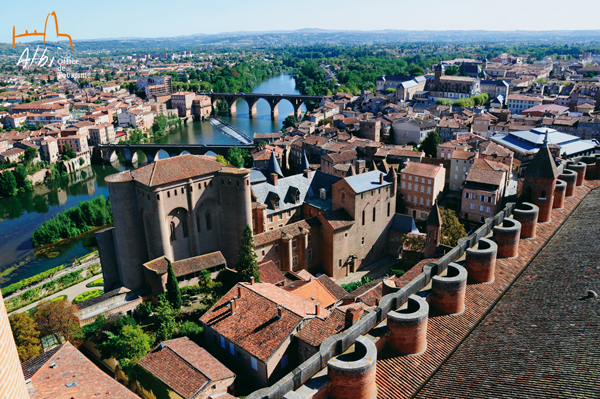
[139,337,235,399]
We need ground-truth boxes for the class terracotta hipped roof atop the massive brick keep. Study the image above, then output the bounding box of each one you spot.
[105,154,222,187]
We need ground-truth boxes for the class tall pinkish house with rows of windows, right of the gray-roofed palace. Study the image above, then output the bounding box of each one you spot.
[399,162,446,220]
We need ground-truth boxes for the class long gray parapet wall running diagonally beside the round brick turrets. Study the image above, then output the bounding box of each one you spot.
[247,202,515,399]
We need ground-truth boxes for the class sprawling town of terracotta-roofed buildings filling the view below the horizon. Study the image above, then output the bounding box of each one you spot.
[0,29,600,399]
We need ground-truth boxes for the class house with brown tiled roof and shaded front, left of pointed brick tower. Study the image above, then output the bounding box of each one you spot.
[460,168,507,223]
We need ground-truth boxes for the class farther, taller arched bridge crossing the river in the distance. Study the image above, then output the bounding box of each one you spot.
[207,93,327,119]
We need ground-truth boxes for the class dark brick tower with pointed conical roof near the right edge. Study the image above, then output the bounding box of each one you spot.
[523,129,559,222]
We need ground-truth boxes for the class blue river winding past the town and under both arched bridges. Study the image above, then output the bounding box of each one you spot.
[0,74,304,287]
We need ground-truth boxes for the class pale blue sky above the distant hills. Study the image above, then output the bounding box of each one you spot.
[0,0,600,43]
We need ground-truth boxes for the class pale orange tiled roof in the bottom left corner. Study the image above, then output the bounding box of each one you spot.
[21,342,139,399]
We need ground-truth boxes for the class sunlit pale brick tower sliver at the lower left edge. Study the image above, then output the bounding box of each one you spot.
[0,294,29,399]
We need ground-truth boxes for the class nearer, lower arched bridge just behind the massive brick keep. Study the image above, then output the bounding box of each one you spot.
[93,143,254,164]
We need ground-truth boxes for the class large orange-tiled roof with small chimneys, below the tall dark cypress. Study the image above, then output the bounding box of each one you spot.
[200,283,329,362]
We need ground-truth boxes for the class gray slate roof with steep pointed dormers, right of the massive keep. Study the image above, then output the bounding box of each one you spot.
[252,171,340,215]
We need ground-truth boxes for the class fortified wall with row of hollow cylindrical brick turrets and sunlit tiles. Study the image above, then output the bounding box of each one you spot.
[248,155,600,399]
